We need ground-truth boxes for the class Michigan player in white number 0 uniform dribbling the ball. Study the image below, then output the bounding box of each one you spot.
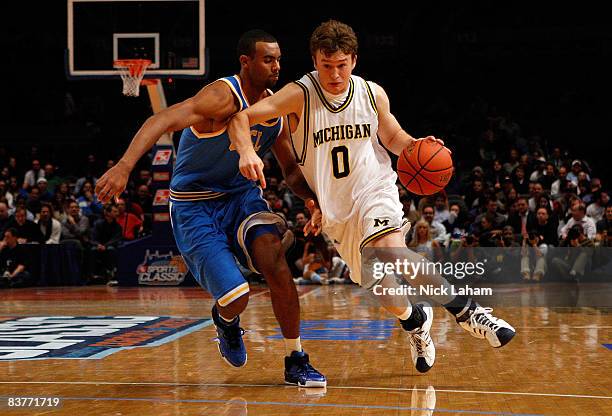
[229,20,515,372]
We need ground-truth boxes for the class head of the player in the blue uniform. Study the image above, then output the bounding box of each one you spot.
[237,29,281,88]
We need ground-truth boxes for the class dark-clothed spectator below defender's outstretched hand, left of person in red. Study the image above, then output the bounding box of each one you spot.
[90,204,121,283]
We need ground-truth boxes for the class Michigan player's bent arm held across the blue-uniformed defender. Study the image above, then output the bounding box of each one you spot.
[228,84,304,188]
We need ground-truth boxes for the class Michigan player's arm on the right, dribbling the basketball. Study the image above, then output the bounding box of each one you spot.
[375,84,444,156]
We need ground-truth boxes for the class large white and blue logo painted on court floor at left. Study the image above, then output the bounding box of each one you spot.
[0,316,212,361]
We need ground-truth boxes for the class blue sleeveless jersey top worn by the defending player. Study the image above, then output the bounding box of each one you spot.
[170,75,283,201]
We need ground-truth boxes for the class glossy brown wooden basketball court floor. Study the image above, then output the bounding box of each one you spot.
[0,284,612,416]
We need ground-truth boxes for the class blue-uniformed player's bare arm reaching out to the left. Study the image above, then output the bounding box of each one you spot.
[96,82,238,203]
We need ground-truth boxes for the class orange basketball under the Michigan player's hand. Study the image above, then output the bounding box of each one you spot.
[397,140,453,195]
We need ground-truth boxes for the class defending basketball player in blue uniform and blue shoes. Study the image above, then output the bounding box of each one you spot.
[96,30,327,387]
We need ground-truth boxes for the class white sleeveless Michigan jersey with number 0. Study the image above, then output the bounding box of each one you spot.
[291,71,401,231]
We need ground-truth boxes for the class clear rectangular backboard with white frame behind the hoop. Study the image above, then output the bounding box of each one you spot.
[66,0,207,79]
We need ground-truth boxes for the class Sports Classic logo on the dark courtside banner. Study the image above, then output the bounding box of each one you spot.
[136,250,187,286]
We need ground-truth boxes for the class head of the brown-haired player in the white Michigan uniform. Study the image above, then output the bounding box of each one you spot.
[310,20,359,94]
